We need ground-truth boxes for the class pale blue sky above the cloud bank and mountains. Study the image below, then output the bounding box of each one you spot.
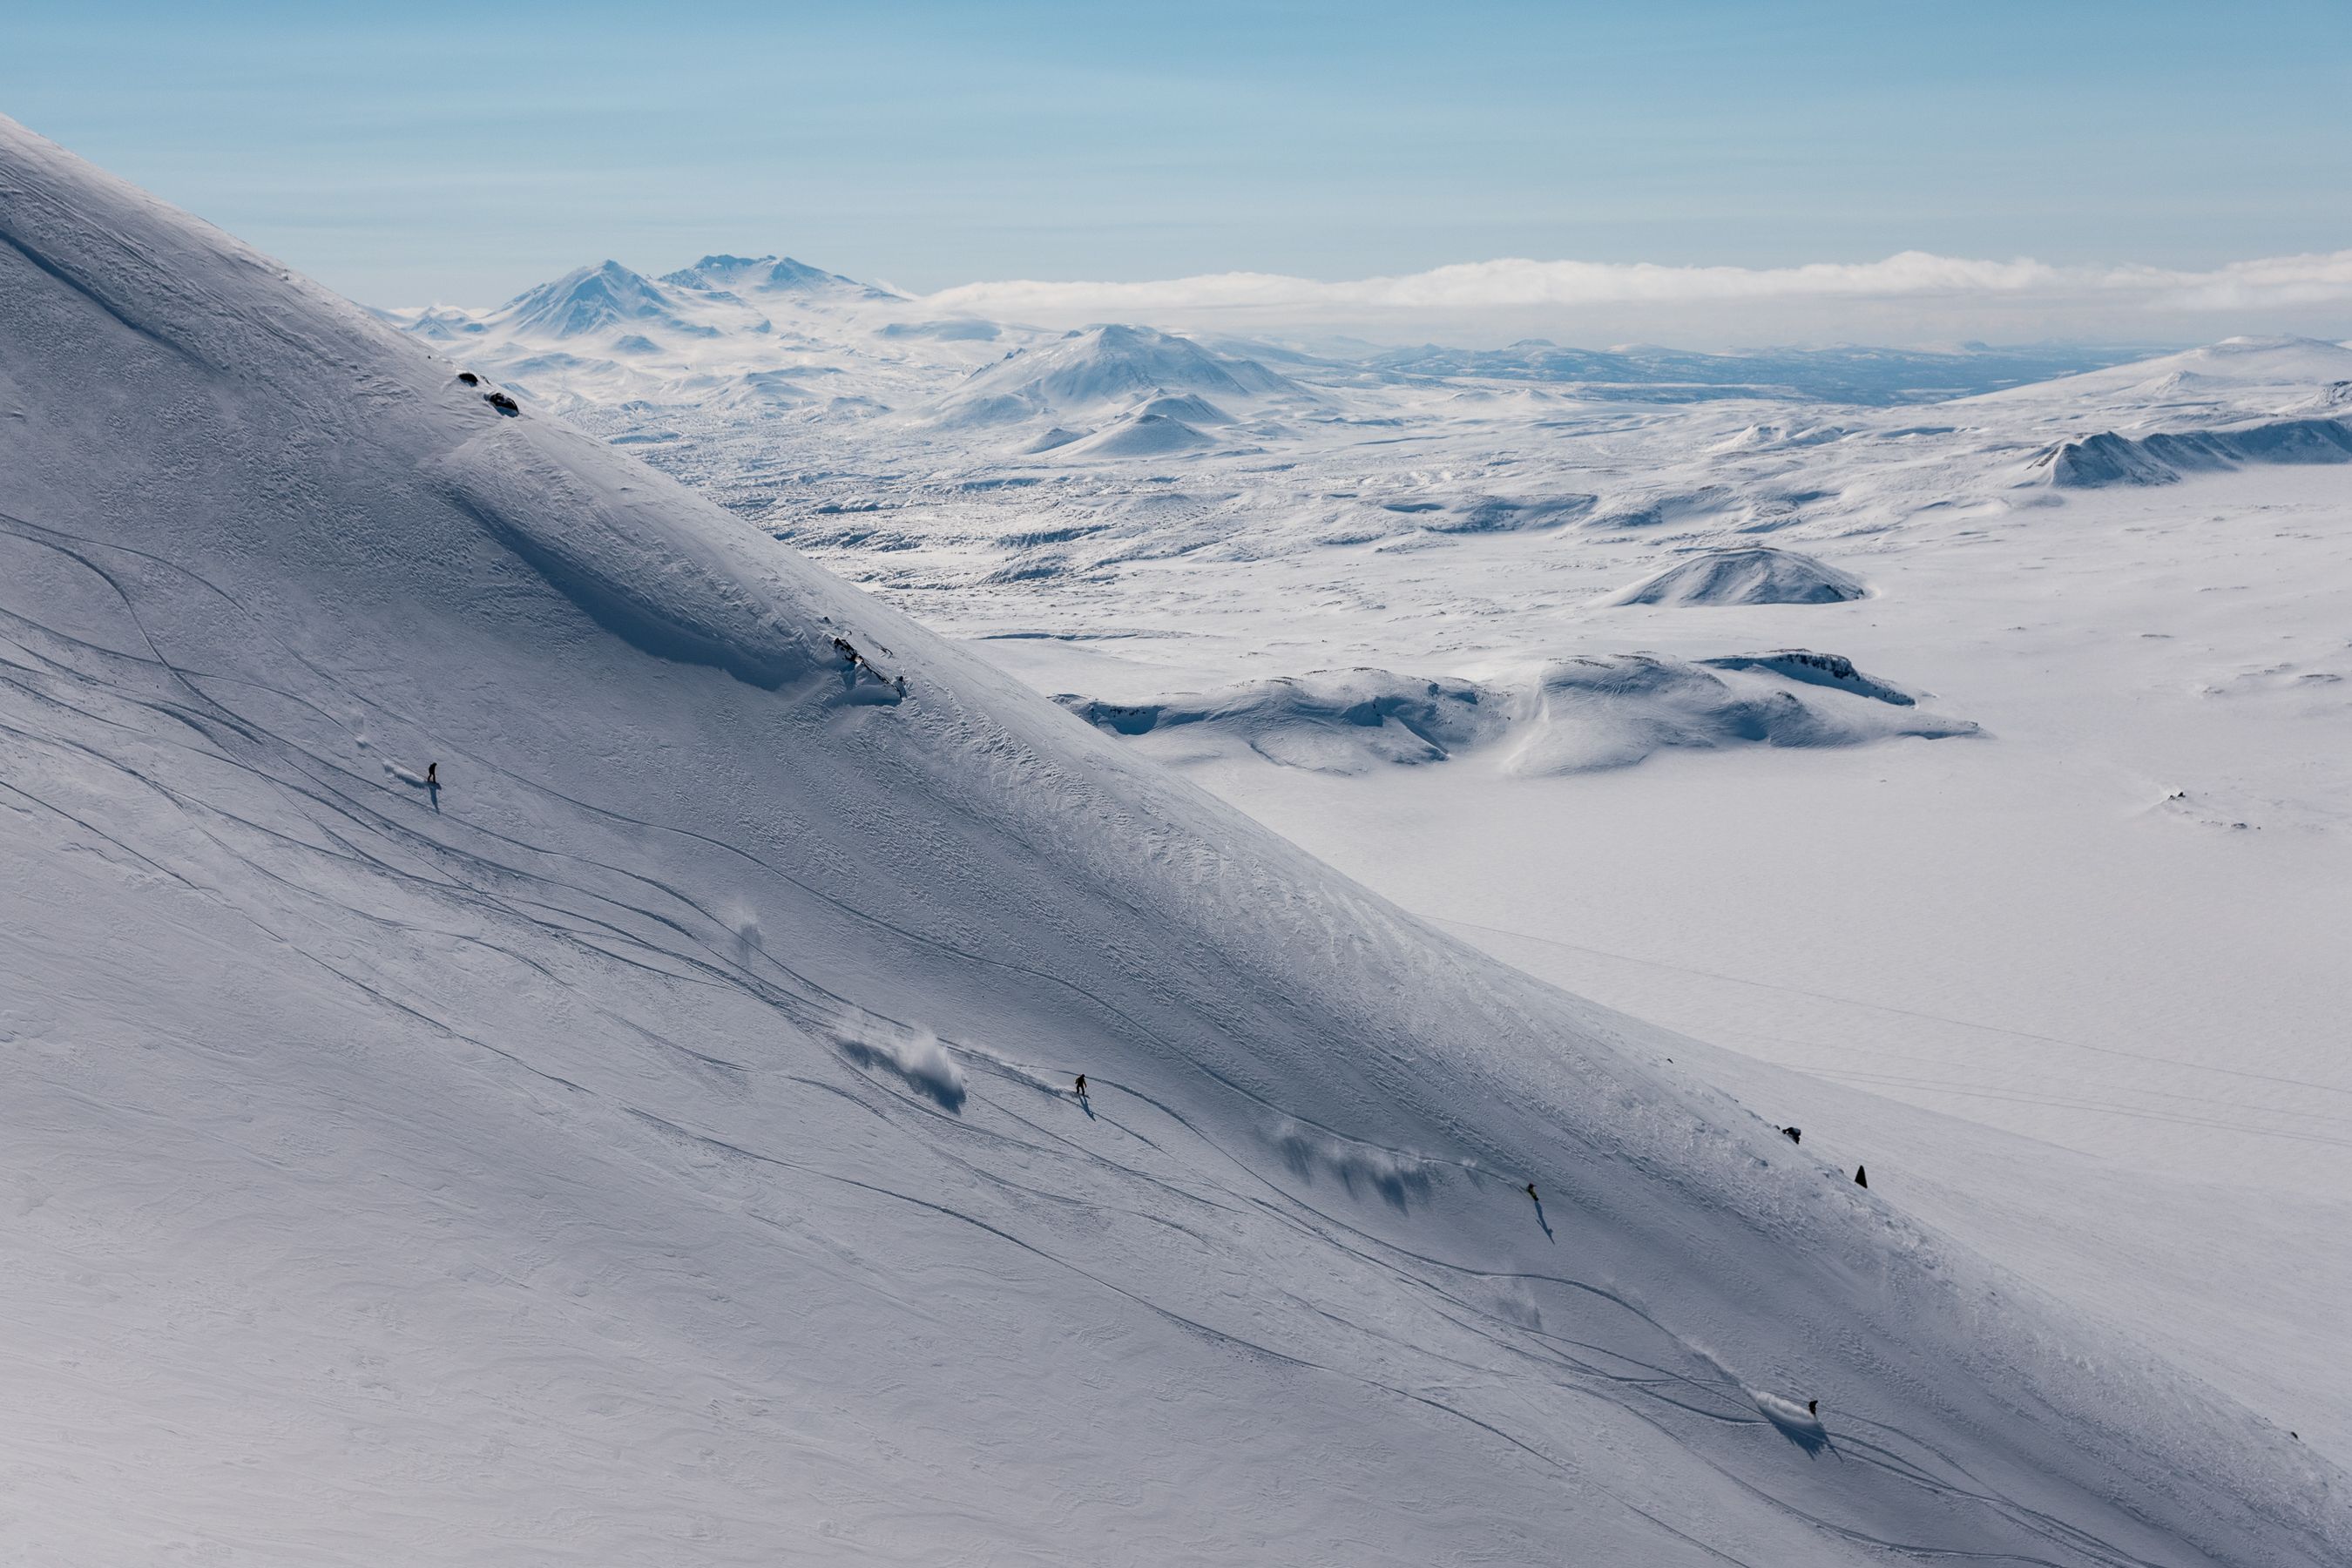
[0,0,2352,320]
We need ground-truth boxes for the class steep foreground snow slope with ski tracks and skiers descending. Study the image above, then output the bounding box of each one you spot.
[0,122,2352,1568]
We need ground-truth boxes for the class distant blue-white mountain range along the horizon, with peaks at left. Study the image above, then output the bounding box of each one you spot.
[386,253,2157,425]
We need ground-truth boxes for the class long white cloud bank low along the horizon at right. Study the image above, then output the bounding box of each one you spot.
[927,249,2352,336]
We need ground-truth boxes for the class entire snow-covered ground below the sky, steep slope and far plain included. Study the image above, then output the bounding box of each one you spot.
[0,120,2352,1568]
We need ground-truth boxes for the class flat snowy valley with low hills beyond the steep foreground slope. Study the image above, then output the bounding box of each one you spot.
[385,240,2352,1495]
